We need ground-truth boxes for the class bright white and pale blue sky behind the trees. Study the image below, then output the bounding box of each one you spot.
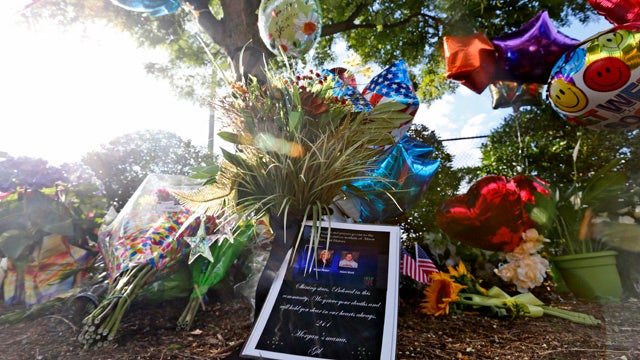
[0,1,611,166]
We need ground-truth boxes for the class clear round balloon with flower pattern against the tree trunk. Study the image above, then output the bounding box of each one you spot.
[258,0,322,58]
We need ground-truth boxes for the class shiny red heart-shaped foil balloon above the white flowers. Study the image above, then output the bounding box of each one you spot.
[436,175,548,252]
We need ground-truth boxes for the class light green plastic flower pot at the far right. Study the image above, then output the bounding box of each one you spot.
[552,251,622,302]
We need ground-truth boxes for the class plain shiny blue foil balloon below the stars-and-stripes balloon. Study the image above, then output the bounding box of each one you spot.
[344,136,440,223]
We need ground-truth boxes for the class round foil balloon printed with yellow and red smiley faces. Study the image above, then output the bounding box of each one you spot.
[547,23,640,130]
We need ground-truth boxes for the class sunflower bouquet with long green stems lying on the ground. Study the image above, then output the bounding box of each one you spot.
[420,262,600,325]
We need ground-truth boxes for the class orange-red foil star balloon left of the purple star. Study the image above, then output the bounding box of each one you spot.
[444,33,497,94]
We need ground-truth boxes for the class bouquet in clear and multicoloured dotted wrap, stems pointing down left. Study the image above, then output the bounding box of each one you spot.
[78,174,206,347]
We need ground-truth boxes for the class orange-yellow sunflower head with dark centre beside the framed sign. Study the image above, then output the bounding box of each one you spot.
[420,272,466,316]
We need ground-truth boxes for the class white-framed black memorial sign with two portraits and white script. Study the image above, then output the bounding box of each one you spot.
[242,223,400,360]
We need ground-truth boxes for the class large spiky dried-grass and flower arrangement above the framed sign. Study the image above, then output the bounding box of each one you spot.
[170,66,410,264]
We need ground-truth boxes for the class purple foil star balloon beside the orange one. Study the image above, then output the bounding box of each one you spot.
[491,11,579,84]
